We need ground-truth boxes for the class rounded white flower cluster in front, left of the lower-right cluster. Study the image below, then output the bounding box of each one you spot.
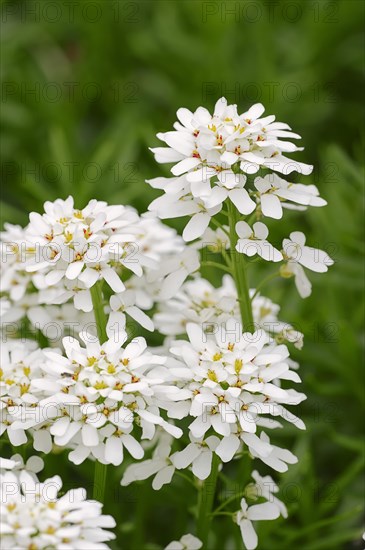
[34,334,182,465]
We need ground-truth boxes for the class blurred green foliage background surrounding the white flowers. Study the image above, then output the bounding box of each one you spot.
[1,0,364,550]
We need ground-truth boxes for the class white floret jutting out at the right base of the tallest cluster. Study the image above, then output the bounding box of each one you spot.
[254,174,327,219]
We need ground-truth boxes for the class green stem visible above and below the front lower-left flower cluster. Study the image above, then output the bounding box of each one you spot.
[90,281,108,502]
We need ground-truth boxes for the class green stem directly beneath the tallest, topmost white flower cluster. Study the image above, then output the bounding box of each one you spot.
[228,202,254,332]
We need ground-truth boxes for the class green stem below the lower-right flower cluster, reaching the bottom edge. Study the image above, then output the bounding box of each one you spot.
[197,453,219,550]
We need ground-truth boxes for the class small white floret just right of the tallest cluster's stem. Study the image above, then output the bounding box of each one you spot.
[236,221,283,262]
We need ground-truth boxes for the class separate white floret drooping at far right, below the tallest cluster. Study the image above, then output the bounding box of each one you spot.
[281,231,334,298]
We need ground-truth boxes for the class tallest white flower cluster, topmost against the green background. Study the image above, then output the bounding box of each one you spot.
[149,98,320,241]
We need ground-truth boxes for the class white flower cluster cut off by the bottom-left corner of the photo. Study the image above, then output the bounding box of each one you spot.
[0,455,116,550]
